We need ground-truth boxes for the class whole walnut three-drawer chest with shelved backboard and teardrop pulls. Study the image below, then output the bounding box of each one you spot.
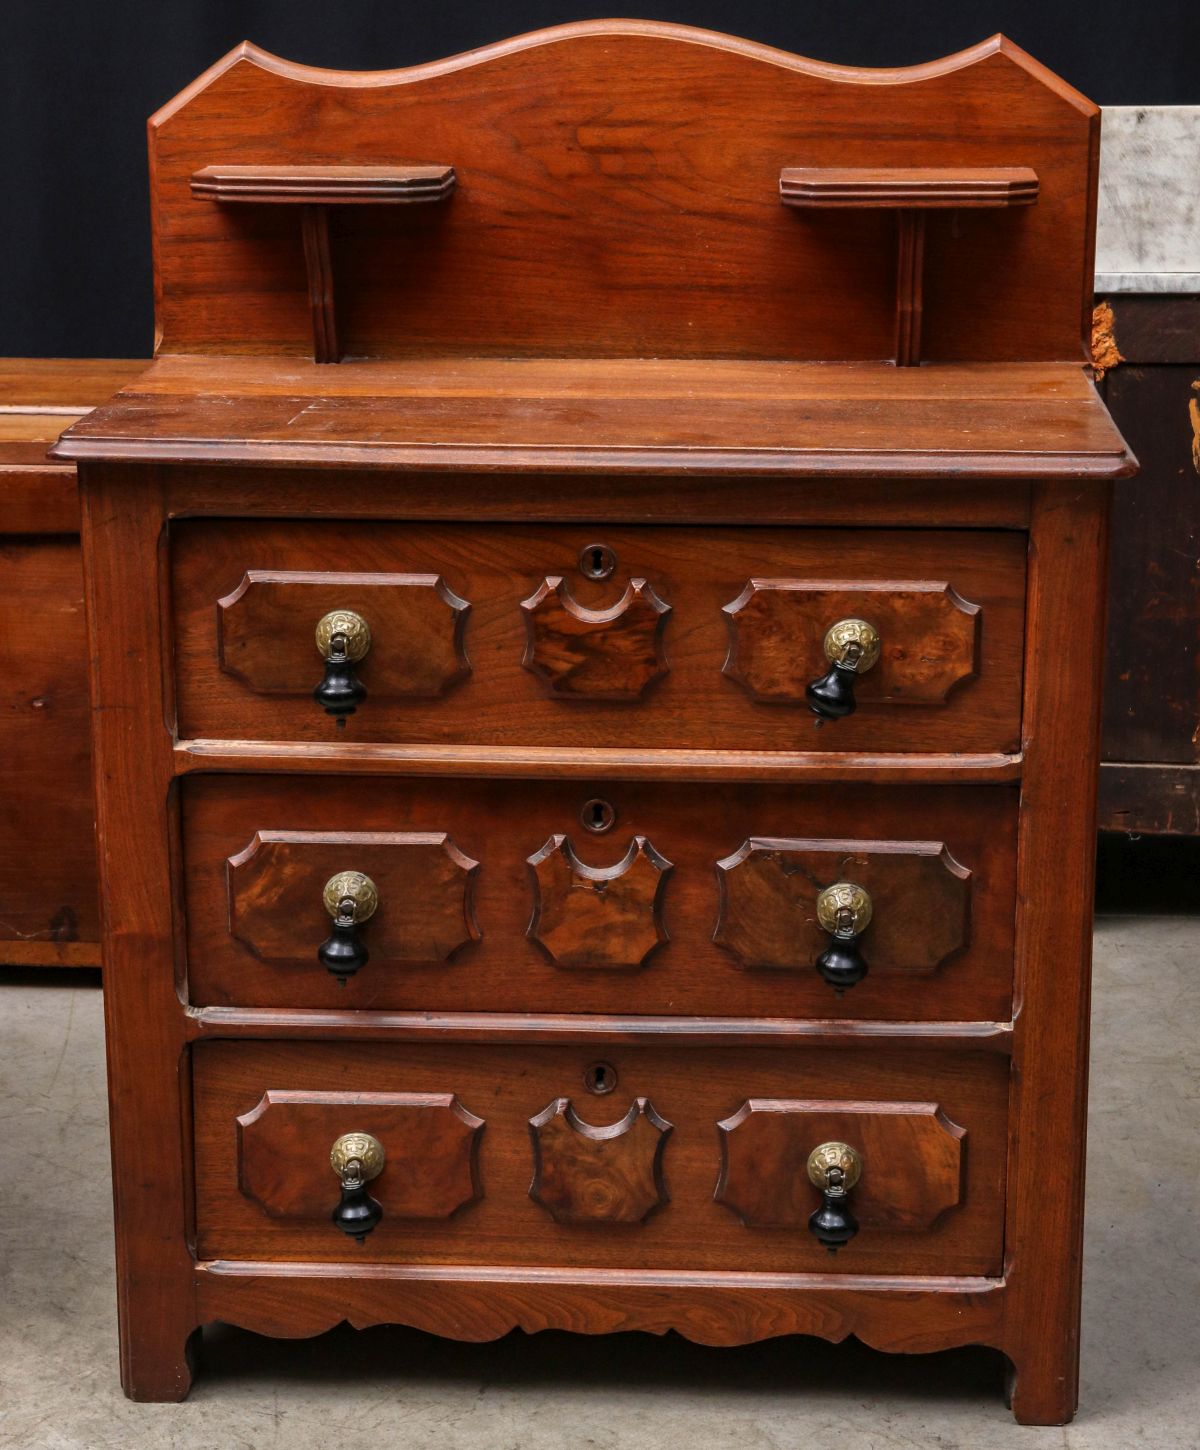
[49,22,1133,1421]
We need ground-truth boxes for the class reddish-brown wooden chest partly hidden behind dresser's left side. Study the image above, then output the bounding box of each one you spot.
[0,358,145,967]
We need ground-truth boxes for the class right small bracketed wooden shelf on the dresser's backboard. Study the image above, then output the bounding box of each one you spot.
[780,167,1038,367]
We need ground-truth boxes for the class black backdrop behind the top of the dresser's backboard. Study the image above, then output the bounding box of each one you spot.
[0,0,1200,357]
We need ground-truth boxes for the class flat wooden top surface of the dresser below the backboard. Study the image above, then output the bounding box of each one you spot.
[54,358,1135,481]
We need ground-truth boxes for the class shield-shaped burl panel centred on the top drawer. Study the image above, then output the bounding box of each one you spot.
[520,576,671,700]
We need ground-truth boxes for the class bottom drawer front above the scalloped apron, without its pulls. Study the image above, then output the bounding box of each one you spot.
[193,1041,1009,1275]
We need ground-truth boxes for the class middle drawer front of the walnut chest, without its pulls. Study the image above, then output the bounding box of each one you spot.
[183,776,1017,1021]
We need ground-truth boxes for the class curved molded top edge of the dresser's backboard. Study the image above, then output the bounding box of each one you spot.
[149,20,1099,129]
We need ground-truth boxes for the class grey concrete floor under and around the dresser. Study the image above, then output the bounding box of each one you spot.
[0,918,1200,1450]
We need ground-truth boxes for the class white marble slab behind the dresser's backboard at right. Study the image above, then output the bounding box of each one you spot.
[1096,106,1200,291]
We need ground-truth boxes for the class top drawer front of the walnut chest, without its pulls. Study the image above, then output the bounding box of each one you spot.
[172,519,1025,753]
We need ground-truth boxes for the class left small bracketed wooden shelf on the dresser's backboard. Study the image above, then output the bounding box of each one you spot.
[191,162,458,363]
